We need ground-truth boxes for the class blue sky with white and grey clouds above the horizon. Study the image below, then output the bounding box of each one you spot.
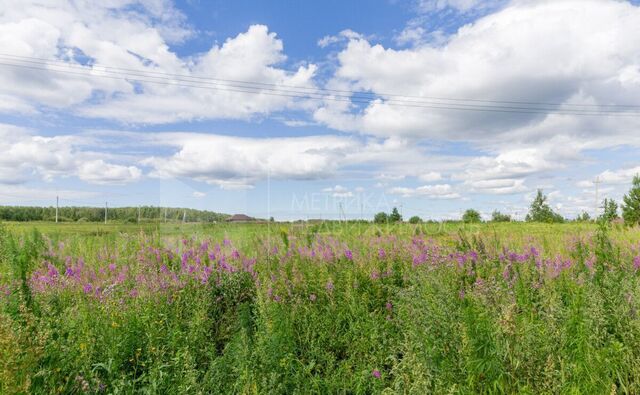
[0,0,640,220]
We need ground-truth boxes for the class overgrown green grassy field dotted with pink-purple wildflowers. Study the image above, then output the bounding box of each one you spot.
[0,223,640,394]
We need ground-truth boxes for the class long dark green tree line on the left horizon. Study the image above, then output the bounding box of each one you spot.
[0,206,229,222]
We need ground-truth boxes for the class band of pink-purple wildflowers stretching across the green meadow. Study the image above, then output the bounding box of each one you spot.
[15,236,640,311]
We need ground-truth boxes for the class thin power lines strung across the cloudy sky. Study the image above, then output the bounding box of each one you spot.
[0,55,640,116]
